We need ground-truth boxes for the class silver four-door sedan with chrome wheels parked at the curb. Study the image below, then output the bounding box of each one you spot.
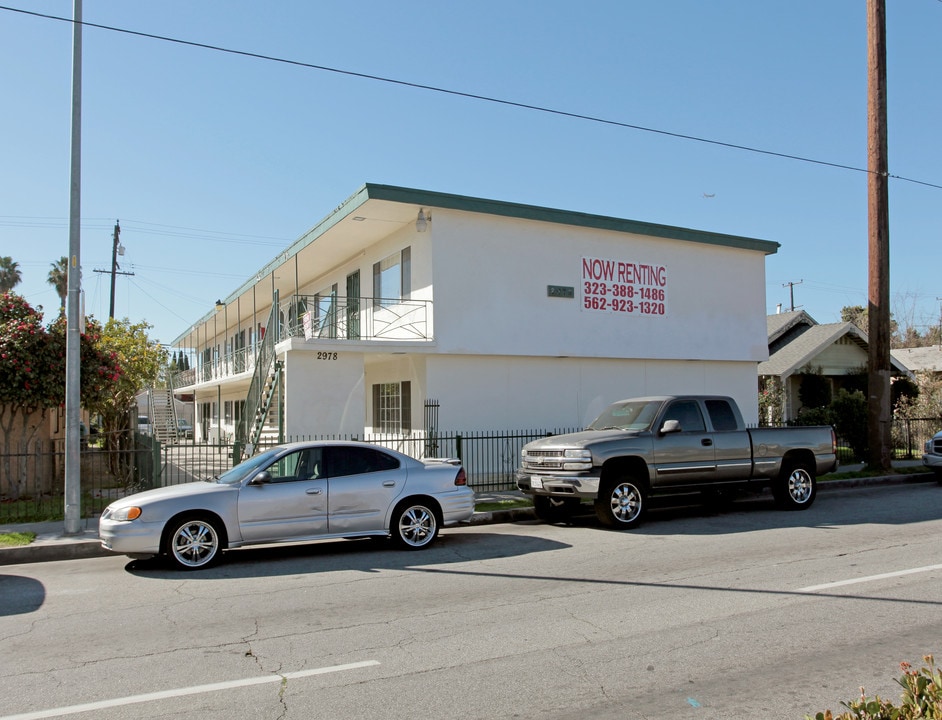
[99,441,474,570]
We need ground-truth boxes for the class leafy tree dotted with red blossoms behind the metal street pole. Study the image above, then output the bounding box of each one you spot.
[0,293,121,496]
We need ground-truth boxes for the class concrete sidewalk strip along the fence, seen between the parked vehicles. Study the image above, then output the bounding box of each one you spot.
[0,470,935,565]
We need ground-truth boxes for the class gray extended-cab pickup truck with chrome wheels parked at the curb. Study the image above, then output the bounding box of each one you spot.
[517,395,837,529]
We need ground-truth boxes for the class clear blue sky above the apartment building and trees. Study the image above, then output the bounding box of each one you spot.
[0,0,942,342]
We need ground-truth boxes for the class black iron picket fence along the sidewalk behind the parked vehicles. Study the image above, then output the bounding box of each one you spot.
[0,418,942,525]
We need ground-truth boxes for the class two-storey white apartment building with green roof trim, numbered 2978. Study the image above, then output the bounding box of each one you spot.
[173,184,778,452]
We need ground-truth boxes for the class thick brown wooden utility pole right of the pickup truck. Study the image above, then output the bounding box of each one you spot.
[867,0,892,470]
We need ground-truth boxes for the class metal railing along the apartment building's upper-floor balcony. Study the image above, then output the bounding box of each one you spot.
[173,295,432,389]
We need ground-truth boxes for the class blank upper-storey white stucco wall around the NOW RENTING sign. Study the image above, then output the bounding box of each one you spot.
[433,211,768,362]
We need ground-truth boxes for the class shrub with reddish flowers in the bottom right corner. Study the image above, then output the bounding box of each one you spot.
[805,655,942,720]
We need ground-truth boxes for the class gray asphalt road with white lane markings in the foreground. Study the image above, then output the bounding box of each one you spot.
[0,483,942,720]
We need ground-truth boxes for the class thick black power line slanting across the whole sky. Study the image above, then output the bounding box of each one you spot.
[0,0,942,190]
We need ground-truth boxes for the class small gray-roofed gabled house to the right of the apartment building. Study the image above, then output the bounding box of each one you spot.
[759,310,909,420]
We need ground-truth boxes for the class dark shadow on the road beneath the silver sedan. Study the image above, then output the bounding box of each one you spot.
[125,529,571,580]
